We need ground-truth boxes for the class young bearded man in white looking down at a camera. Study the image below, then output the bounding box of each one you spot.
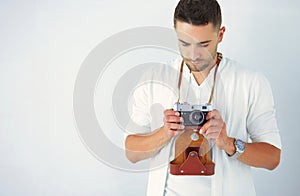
[125,0,281,195]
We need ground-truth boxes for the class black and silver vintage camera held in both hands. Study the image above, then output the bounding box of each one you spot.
[173,102,212,127]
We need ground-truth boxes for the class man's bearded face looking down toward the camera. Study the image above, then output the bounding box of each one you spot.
[175,21,225,72]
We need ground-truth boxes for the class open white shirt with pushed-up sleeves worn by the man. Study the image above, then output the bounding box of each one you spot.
[127,55,281,196]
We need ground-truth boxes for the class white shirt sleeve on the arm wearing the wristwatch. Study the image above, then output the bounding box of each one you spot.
[247,73,281,149]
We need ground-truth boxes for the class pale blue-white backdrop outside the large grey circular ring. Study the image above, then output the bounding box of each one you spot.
[0,0,300,196]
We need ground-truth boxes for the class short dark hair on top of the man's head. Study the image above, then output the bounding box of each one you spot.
[174,0,222,28]
